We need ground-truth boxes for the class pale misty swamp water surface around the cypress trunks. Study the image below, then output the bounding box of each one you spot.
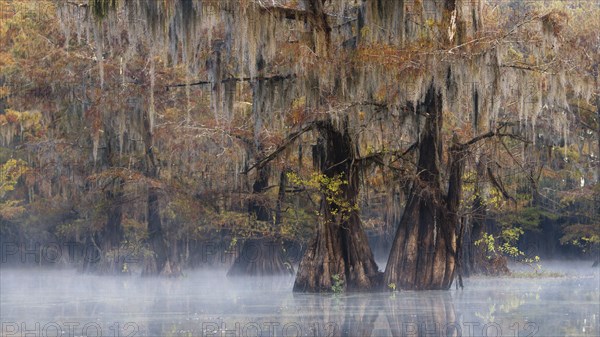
[0,263,600,337]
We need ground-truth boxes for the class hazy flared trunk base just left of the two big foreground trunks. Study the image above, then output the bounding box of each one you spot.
[227,238,294,277]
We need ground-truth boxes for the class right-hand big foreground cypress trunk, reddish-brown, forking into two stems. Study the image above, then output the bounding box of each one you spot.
[384,84,464,290]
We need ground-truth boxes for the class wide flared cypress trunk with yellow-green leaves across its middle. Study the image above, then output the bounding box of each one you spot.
[294,121,381,292]
